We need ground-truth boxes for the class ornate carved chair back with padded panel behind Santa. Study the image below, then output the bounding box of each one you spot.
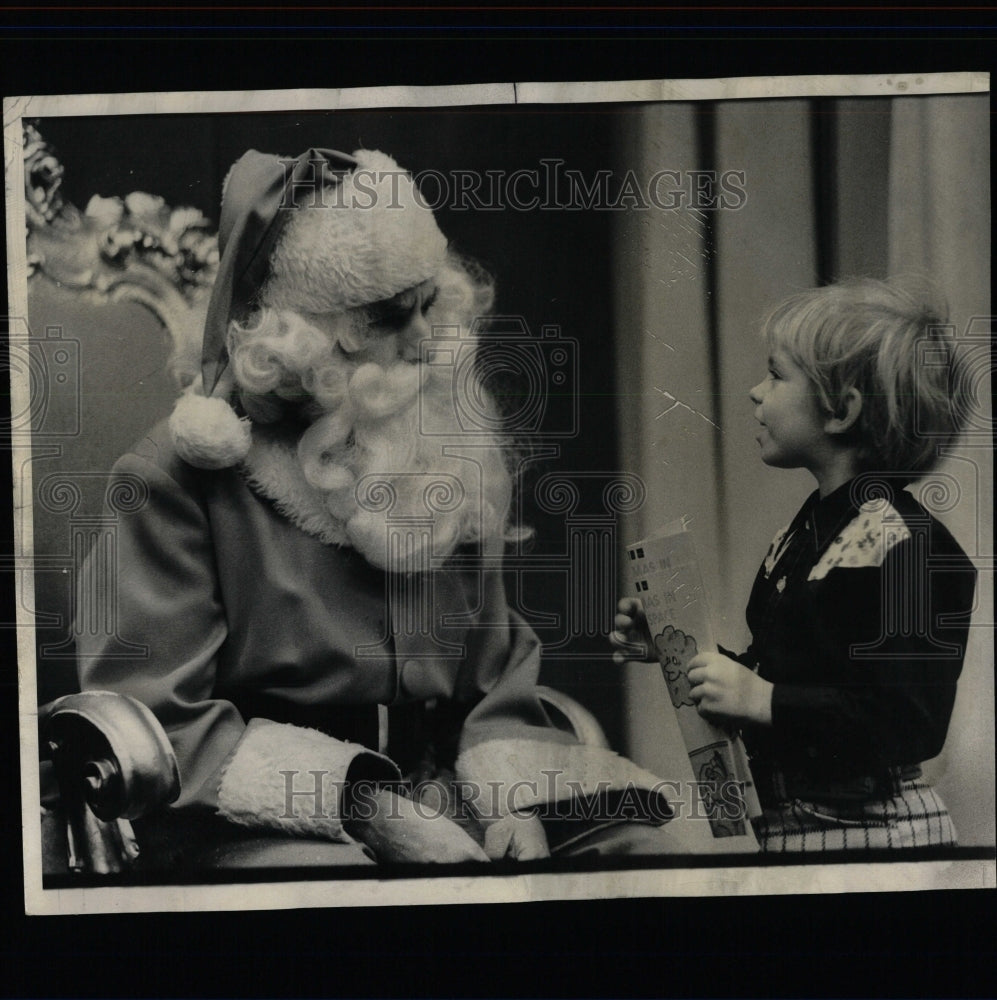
[21,125,218,703]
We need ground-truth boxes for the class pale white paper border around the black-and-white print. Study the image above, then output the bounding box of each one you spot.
[4,72,997,914]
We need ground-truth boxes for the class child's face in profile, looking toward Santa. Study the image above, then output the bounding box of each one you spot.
[749,348,828,471]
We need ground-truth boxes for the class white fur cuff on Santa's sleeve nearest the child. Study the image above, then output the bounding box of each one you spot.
[456,739,663,823]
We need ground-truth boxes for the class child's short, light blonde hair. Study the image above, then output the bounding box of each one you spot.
[762,278,960,479]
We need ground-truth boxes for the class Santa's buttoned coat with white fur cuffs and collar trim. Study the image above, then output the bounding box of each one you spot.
[78,424,658,839]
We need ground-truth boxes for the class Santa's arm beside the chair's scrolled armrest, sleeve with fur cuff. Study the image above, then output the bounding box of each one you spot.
[78,448,400,840]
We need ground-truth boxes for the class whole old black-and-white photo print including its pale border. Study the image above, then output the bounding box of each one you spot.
[4,73,995,913]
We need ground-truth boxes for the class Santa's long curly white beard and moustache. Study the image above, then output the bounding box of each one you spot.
[235,322,515,573]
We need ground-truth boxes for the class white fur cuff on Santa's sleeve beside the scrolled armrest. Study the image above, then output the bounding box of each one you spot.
[218,719,401,842]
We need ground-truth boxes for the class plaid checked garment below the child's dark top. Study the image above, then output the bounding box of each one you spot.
[754,778,956,854]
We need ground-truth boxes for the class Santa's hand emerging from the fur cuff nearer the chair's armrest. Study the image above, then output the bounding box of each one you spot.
[343,789,488,864]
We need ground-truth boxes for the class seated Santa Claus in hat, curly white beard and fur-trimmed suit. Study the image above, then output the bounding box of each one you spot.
[79,143,670,864]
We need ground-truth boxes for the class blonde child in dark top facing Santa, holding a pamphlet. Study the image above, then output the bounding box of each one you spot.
[612,280,975,851]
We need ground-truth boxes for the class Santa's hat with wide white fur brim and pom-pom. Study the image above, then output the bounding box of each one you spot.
[170,149,447,469]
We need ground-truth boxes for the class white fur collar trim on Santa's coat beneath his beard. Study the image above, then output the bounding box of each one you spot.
[241,426,349,545]
